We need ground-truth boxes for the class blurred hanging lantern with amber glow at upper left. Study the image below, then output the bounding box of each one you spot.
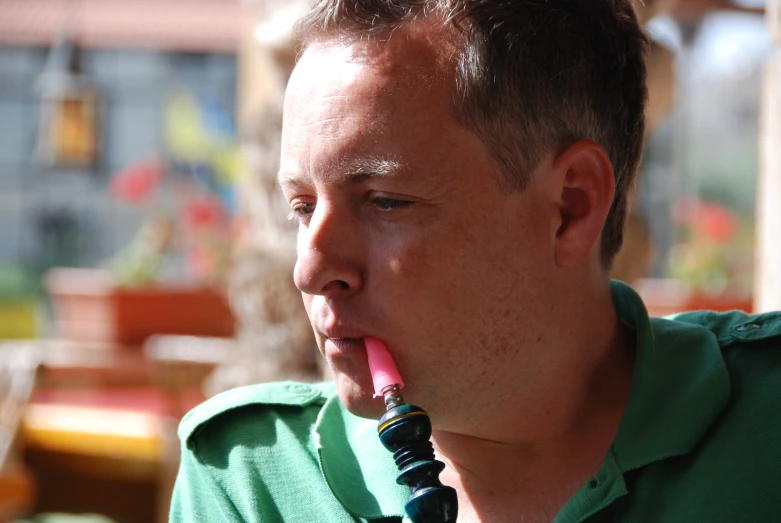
[36,37,100,169]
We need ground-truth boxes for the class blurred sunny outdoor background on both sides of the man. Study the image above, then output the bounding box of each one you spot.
[0,0,781,523]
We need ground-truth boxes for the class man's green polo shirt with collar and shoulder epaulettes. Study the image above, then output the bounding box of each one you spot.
[170,282,781,523]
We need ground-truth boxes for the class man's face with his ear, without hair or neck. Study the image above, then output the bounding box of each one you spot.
[280,30,555,426]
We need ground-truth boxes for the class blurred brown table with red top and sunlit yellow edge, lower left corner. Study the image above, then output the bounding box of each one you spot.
[12,341,215,523]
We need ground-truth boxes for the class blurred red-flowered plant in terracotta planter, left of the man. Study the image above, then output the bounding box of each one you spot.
[44,97,238,345]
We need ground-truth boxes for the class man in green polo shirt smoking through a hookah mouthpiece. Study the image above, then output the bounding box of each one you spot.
[171,0,781,522]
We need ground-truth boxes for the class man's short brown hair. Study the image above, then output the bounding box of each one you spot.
[297,0,647,267]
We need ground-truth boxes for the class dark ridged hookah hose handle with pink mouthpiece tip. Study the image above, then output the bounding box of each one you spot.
[364,337,458,523]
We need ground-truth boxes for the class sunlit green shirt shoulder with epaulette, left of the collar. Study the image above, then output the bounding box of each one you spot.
[171,382,360,523]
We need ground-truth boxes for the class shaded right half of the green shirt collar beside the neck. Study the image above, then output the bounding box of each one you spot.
[611,281,730,472]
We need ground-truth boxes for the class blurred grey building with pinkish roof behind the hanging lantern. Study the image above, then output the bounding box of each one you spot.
[0,0,242,300]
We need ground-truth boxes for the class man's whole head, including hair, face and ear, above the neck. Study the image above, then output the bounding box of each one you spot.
[280,0,644,427]
